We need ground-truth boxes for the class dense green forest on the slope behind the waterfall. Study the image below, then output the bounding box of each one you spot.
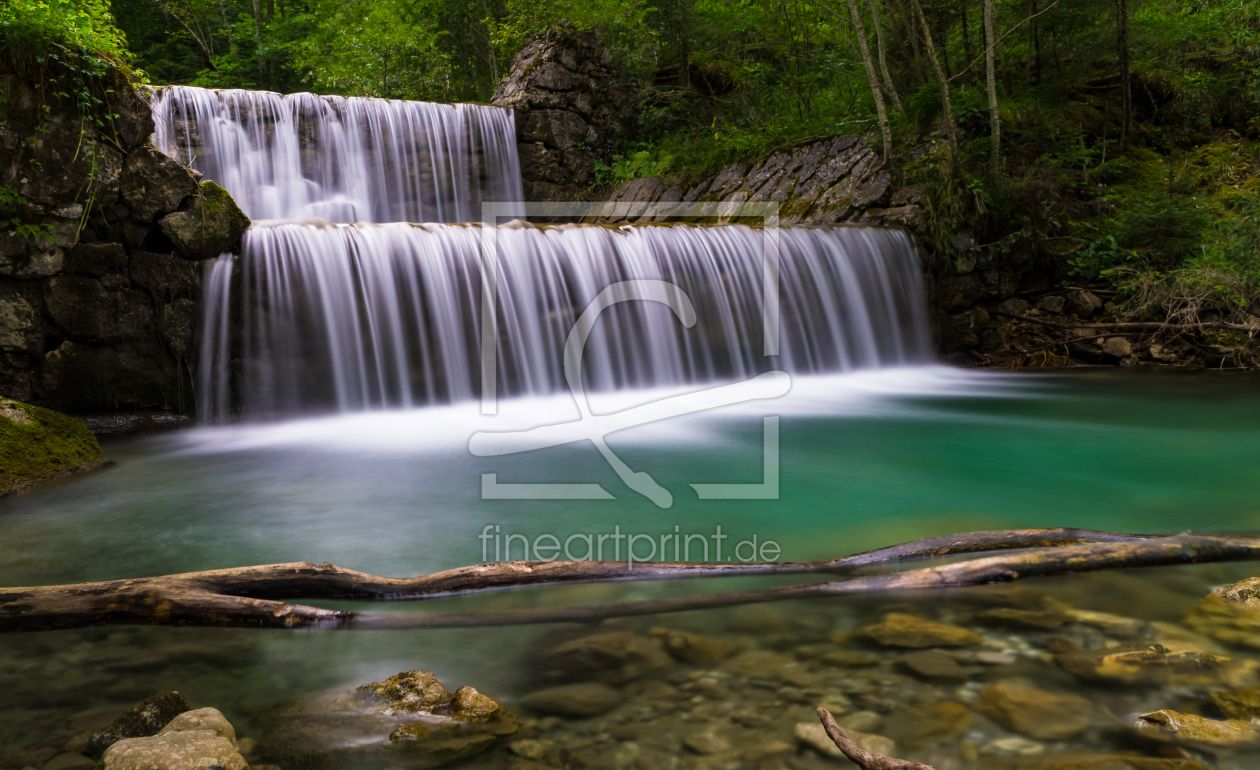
[0,0,1260,342]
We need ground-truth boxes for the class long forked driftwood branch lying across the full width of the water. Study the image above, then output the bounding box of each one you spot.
[0,529,1260,633]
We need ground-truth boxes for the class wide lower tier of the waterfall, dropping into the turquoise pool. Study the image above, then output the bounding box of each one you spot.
[202,222,931,418]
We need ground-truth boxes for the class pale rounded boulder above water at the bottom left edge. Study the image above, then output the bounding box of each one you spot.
[102,708,247,770]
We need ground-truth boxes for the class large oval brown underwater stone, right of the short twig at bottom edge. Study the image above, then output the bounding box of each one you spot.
[973,682,1094,741]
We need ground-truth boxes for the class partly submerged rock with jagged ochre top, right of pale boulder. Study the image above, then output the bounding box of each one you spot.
[257,670,520,770]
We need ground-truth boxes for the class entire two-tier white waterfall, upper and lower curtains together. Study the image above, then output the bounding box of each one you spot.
[172,86,930,421]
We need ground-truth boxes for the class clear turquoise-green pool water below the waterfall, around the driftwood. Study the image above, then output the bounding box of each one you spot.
[0,367,1260,766]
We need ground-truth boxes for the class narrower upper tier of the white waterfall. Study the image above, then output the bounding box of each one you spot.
[154,86,524,222]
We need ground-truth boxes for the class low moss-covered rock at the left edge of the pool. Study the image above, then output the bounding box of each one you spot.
[0,398,105,494]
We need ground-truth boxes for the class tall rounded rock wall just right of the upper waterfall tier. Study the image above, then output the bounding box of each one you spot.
[493,30,636,200]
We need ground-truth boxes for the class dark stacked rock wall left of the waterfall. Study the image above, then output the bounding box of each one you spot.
[0,65,249,413]
